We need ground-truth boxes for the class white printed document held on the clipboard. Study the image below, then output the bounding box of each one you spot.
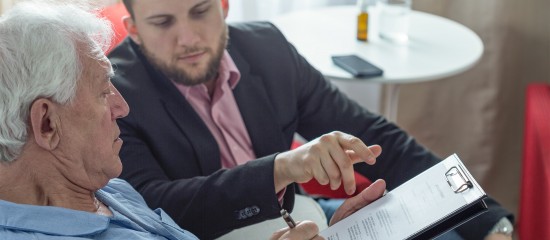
[319,154,486,240]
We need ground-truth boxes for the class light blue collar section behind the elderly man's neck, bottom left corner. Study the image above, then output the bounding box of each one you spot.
[0,200,110,236]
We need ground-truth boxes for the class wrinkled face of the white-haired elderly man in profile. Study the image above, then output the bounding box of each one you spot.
[57,55,129,190]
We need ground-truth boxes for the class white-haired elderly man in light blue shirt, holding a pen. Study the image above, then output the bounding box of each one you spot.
[0,1,385,240]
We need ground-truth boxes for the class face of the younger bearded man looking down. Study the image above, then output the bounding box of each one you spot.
[127,0,227,85]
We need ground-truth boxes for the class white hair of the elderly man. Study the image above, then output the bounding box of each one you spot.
[0,0,112,163]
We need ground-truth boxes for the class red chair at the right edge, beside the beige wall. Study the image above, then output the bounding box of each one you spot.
[518,83,550,239]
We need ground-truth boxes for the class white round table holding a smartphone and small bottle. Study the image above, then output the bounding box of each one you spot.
[273,6,483,120]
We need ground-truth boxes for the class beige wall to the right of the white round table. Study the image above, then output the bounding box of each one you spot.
[397,0,550,225]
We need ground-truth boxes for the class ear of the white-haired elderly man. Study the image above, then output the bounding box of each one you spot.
[29,98,60,150]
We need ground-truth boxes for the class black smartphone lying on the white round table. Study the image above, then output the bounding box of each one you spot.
[332,54,384,78]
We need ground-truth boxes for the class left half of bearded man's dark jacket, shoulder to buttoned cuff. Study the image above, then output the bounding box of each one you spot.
[109,39,295,239]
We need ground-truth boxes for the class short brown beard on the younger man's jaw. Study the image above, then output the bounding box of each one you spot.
[140,26,228,86]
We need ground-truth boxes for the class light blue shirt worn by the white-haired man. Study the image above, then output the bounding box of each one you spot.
[0,179,198,240]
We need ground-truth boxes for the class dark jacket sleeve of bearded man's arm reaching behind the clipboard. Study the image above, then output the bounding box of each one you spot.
[280,24,513,239]
